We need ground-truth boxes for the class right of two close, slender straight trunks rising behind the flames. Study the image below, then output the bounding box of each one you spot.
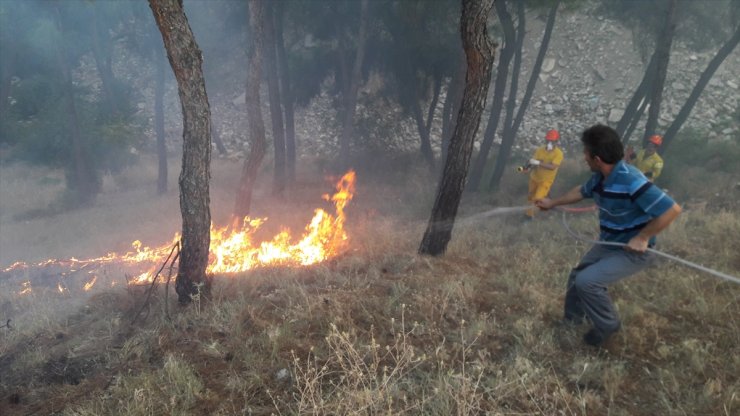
[275,2,296,184]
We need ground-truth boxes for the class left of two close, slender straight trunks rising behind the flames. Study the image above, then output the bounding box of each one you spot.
[263,2,285,195]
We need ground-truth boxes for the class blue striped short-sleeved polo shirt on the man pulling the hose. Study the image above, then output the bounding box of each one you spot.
[581,160,675,246]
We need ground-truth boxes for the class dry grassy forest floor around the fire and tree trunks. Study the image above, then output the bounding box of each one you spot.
[0,154,740,416]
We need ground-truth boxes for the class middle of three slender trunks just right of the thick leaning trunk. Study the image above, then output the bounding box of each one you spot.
[488,0,525,191]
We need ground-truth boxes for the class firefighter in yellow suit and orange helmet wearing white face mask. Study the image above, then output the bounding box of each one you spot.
[527,130,563,218]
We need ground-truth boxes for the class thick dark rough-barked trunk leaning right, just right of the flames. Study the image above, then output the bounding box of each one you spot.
[419,0,495,256]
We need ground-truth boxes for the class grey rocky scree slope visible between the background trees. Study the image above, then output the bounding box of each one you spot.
[107,0,740,159]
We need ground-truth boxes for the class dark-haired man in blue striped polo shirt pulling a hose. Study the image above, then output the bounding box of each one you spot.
[535,124,681,346]
